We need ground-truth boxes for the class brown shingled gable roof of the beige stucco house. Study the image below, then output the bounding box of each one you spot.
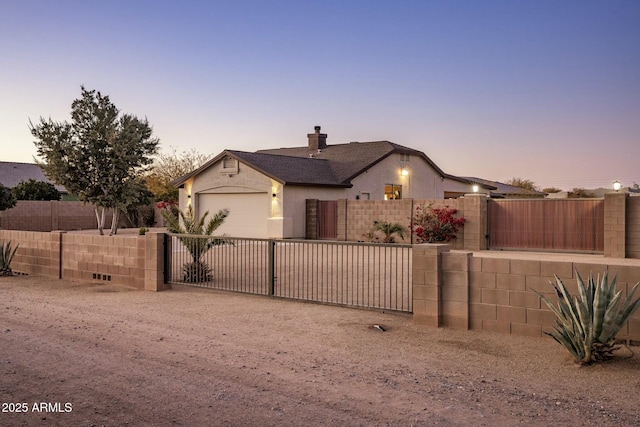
[172,141,448,187]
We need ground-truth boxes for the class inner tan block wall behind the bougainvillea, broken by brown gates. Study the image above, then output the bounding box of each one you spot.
[306,193,640,259]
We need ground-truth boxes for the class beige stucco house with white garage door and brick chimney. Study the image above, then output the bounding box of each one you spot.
[172,126,470,238]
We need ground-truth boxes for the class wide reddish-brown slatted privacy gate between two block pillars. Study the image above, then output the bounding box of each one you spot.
[487,199,604,253]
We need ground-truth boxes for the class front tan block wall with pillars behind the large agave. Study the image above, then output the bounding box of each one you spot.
[412,244,640,344]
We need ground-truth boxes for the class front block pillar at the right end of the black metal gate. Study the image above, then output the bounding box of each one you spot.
[412,244,449,328]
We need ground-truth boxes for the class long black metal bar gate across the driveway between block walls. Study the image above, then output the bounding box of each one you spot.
[165,234,412,312]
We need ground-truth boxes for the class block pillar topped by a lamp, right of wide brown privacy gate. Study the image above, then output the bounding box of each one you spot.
[604,193,627,258]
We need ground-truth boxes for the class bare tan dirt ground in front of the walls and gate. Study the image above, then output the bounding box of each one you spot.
[0,276,640,427]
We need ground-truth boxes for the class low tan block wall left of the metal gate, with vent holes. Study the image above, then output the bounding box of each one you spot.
[0,230,170,291]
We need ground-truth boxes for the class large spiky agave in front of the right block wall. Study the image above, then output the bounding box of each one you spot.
[535,271,640,364]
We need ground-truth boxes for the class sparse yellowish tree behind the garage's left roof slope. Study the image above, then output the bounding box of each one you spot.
[145,147,211,202]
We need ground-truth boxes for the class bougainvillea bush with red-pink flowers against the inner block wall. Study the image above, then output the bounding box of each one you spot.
[411,204,465,243]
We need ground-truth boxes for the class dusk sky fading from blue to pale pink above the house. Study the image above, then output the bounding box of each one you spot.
[0,0,640,189]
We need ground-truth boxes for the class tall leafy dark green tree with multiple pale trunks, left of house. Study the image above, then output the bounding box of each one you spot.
[29,86,158,235]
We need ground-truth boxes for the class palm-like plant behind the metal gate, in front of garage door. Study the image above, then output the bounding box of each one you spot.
[162,205,233,282]
